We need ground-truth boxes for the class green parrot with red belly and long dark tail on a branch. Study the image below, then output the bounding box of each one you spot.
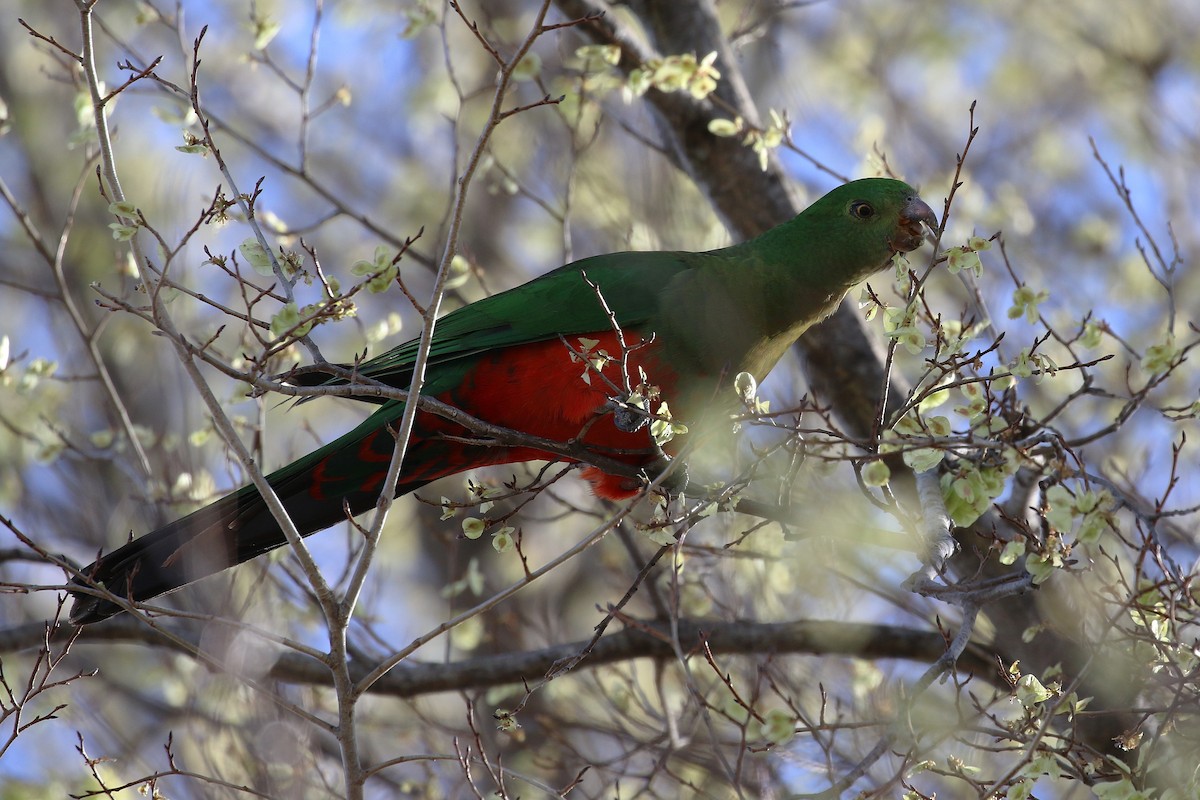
[70,178,937,625]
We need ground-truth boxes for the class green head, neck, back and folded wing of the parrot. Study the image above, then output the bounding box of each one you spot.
[324,179,932,395]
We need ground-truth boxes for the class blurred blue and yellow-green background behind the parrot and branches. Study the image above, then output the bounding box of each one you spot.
[0,0,1200,799]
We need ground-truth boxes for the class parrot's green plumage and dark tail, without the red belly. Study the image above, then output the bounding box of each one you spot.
[71,179,936,624]
